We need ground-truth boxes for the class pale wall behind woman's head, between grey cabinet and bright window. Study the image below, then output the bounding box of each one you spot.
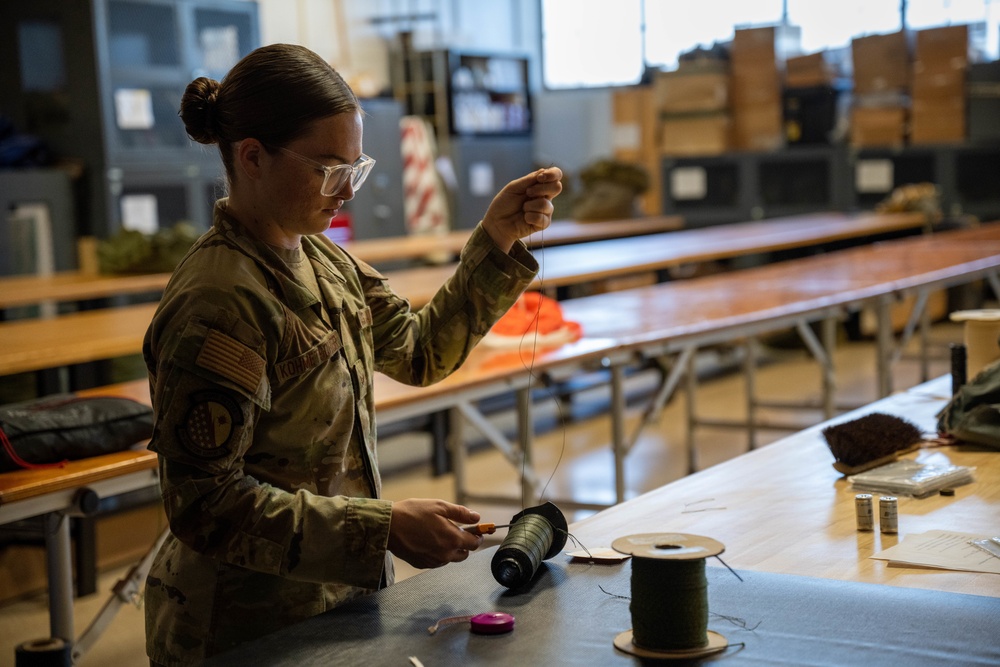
[250,0,612,172]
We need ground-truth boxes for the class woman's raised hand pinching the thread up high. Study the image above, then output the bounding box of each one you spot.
[483,167,562,252]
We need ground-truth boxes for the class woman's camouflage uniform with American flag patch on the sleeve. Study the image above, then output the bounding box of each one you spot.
[143,200,538,665]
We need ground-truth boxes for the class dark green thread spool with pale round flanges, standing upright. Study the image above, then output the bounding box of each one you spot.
[611,533,729,659]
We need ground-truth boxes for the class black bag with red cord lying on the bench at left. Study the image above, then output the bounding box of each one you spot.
[0,394,153,472]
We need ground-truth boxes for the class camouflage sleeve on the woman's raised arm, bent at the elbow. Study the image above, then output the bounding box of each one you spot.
[362,224,538,385]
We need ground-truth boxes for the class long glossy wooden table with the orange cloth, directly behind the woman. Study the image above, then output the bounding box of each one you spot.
[0,217,1000,634]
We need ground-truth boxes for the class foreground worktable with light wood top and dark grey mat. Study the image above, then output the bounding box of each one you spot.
[195,378,1000,667]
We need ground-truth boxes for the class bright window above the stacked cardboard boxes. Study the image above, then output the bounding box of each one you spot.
[541,0,1000,89]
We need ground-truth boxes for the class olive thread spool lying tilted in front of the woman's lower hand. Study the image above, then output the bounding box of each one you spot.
[490,502,569,588]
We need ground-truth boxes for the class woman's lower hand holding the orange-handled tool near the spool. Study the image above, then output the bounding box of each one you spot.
[388,498,483,569]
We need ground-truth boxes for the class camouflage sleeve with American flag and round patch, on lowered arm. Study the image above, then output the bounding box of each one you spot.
[147,290,391,588]
